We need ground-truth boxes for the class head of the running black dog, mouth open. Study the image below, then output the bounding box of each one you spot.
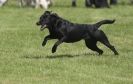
[36,11,58,31]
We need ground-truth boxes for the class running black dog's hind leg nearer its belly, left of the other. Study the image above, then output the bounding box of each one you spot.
[85,39,103,55]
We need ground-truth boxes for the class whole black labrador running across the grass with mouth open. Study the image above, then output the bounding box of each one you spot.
[36,11,118,55]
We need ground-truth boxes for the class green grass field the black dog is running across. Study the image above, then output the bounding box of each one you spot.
[0,0,133,84]
